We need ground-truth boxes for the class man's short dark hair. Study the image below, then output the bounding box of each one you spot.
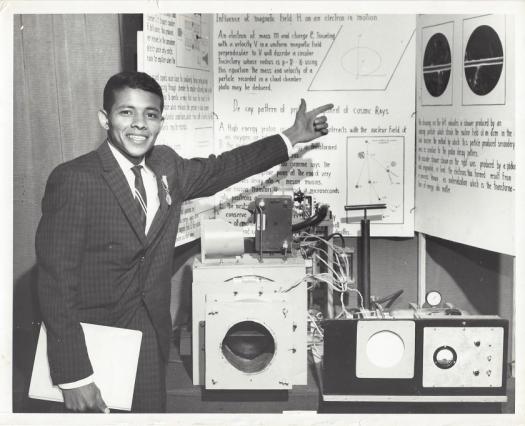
[103,71,164,113]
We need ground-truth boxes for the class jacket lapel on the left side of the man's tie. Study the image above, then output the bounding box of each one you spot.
[97,142,147,245]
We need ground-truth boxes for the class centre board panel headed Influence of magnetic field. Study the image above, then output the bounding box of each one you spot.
[213,14,416,236]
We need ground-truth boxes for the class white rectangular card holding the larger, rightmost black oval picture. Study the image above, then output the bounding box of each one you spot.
[463,15,506,105]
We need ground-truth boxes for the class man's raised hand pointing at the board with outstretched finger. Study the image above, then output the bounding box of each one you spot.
[283,99,334,145]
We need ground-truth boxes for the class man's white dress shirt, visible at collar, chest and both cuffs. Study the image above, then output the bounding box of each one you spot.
[58,133,294,389]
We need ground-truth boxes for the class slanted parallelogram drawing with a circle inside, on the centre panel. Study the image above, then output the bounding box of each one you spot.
[308,15,414,91]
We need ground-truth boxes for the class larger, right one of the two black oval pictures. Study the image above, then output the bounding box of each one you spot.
[465,25,503,96]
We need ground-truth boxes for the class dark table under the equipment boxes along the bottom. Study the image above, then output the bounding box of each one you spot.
[166,334,514,413]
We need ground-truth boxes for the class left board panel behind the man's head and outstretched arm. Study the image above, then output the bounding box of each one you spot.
[137,14,215,245]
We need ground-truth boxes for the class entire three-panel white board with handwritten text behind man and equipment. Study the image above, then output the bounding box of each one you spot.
[138,14,515,254]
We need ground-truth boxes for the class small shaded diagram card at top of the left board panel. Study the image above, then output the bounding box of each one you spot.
[177,13,210,71]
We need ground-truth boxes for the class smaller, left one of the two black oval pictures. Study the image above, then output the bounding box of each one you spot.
[423,33,451,98]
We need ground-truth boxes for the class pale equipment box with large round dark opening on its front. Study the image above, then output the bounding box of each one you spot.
[192,255,307,390]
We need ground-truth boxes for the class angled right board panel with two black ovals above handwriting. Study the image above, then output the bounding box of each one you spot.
[416,15,516,255]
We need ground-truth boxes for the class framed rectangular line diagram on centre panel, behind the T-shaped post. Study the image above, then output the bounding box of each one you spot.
[346,136,405,224]
